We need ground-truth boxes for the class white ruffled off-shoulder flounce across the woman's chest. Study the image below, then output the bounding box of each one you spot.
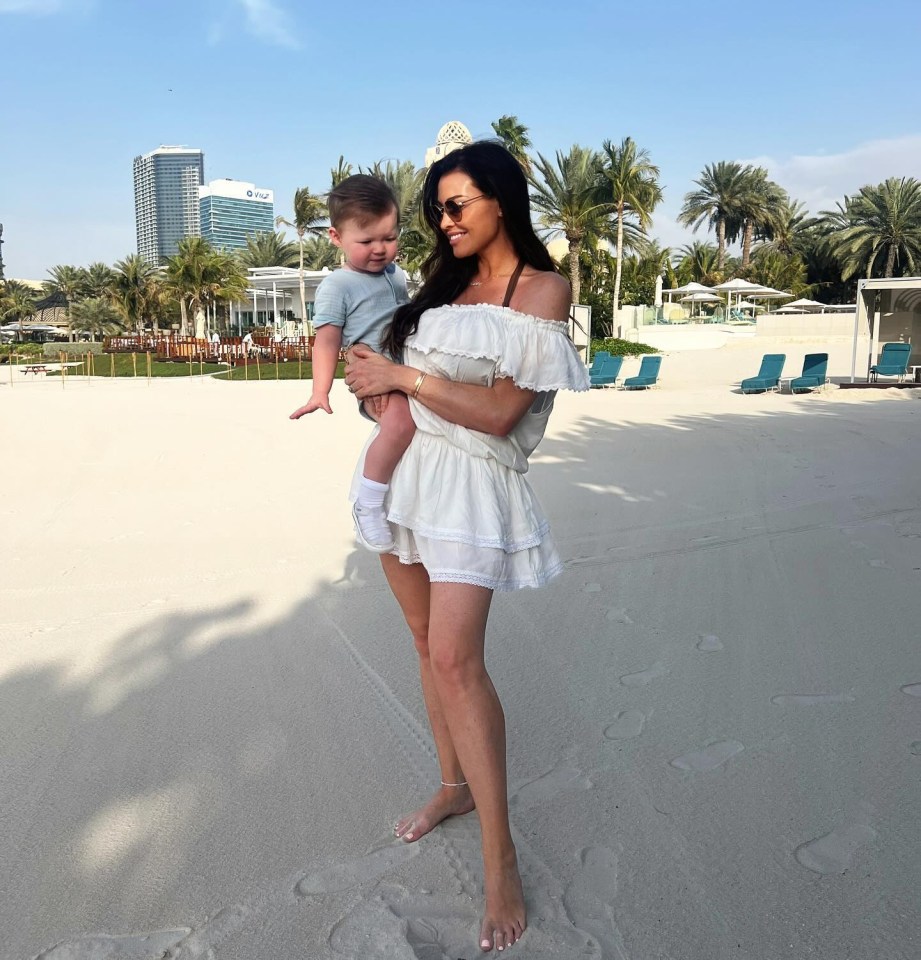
[406,303,590,392]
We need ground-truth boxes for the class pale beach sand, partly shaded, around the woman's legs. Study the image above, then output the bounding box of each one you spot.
[0,340,921,960]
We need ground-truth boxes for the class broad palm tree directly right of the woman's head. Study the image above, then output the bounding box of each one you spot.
[531,144,611,303]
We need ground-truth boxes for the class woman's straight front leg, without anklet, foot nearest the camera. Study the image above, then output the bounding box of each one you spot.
[428,583,526,950]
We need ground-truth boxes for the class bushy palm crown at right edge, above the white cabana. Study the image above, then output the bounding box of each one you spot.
[822,177,921,280]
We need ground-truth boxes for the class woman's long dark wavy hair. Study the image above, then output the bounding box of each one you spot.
[382,140,556,358]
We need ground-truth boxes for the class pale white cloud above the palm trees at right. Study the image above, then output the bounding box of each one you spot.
[744,134,921,214]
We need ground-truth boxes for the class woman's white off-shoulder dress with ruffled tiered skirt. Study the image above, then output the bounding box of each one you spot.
[352,304,589,590]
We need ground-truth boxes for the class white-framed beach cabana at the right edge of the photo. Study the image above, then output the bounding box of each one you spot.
[851,277,921,383]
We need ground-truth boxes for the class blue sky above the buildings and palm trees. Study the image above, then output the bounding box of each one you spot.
[0,0,921,279]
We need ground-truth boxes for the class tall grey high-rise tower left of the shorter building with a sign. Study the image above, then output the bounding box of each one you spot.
[134,147,205,264]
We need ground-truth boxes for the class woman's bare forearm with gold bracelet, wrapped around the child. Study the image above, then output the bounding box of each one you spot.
[345,344,537,437]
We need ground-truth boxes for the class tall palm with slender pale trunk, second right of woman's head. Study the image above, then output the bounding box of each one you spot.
[602,137,662,318]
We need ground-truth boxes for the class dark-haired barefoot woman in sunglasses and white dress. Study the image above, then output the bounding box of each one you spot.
[346,142,588,950]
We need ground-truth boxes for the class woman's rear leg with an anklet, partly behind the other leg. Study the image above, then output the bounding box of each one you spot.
[381,554,473,843]
